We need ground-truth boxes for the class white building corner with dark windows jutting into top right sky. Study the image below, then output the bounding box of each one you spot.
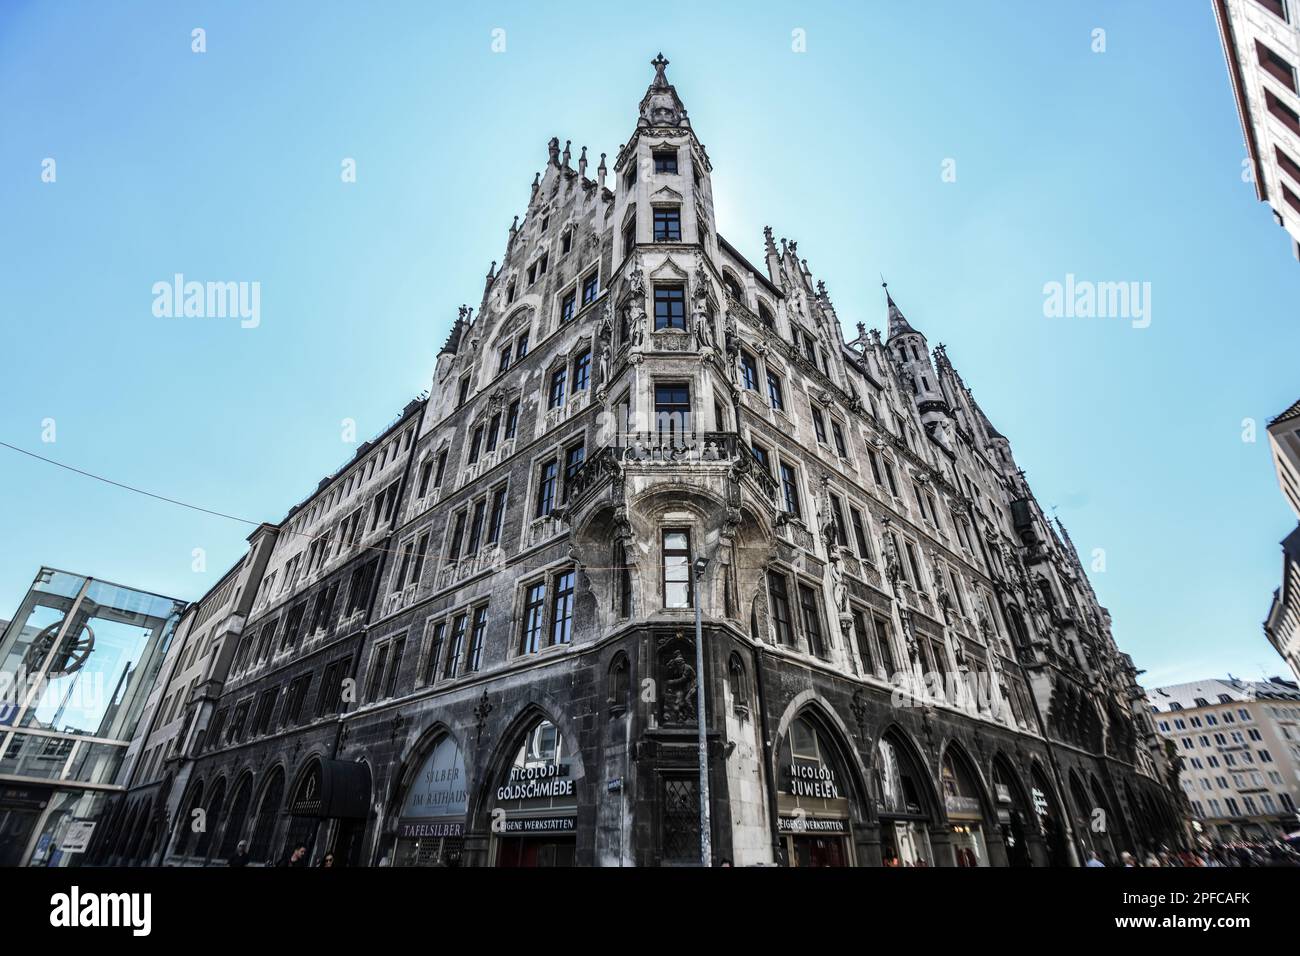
[1213,0,1300,259]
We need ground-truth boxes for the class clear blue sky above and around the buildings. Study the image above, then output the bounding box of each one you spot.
[0,1,1300,683]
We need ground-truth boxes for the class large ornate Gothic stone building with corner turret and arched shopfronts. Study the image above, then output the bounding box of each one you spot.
[94,56,1182,866]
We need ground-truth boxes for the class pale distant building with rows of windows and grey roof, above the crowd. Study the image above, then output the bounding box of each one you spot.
[1147,678,1300,843]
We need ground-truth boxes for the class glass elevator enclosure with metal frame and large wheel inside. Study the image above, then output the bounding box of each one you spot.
[0,567,185,866]
